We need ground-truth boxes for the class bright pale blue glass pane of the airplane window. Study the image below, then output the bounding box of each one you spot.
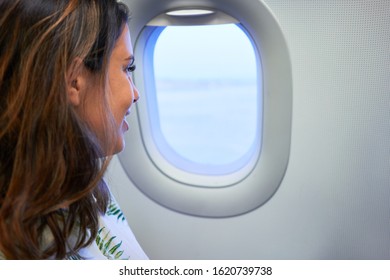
[152,24,261,174]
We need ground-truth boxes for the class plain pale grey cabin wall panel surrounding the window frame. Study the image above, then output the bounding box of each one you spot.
[106,0,390,259]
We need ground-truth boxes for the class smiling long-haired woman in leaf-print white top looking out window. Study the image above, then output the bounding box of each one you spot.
[0,0,147,259]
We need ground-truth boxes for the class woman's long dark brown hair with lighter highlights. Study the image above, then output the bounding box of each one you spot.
[0,0,128,259]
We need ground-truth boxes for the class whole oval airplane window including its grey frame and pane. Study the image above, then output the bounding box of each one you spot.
[119,1,292,214]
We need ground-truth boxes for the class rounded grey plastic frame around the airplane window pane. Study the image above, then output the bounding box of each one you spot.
[119,1,292,217]
